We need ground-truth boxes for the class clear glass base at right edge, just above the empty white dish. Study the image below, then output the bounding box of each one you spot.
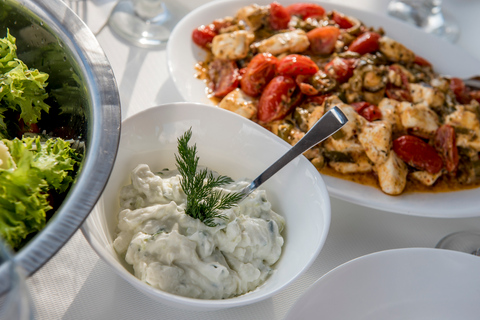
[436,231,480,256]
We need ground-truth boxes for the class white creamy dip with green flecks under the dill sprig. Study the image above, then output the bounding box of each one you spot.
[114,164,285,299]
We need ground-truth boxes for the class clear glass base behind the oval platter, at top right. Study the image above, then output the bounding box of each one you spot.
[387,0,460,42]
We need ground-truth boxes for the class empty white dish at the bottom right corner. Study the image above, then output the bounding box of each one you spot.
[284,248,480,320]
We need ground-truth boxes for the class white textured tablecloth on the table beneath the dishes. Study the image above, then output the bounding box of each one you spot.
[27,0,480,320]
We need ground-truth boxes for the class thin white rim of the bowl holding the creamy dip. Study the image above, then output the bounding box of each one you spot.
[81,102,331,311]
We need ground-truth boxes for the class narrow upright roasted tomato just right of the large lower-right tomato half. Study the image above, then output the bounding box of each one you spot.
[434,124,459,172]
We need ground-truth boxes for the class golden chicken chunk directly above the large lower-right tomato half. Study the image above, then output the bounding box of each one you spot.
[398,102,439,135]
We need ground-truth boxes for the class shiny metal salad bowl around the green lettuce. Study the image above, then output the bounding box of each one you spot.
[0,0,121,296]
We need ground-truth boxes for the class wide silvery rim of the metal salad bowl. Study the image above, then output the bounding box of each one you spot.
[0,0,121,280]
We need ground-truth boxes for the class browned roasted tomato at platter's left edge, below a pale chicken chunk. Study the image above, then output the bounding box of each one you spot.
[208,59,240,98]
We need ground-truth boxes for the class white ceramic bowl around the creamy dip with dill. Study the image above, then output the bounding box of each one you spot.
[82,103,331,310]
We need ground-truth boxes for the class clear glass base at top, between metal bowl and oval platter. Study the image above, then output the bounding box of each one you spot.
[108,0,178,48]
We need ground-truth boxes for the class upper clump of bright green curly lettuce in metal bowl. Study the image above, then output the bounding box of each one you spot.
[0,30,50,138]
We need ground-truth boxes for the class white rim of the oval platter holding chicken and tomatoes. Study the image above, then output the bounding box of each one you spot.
[167,0,480,218]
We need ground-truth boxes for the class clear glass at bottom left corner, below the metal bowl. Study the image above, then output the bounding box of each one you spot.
[0,239,34,320]
